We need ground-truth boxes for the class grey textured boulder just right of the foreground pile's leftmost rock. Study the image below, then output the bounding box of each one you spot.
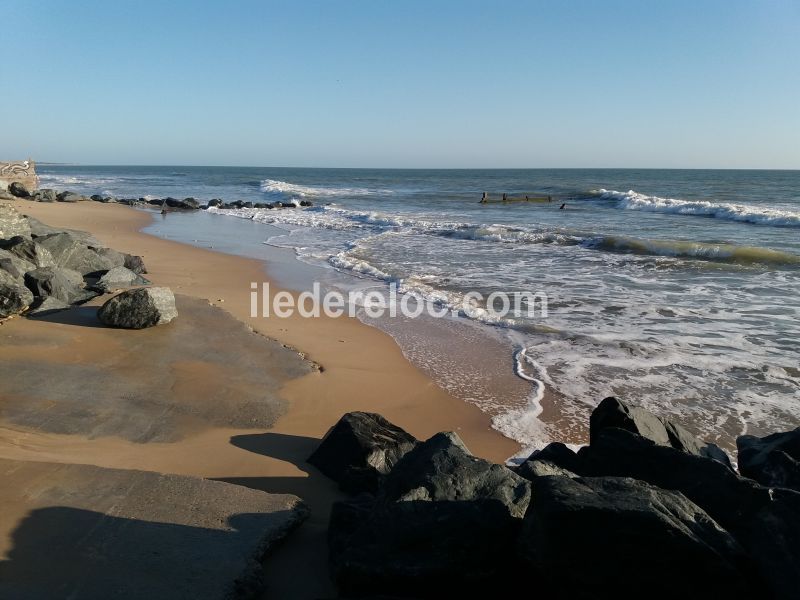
[380,432,531,519]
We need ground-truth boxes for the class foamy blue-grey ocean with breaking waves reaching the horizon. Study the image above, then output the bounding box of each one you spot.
[39,165,800,451]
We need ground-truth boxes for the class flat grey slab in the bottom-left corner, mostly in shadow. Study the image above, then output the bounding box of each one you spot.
[0,459,308,600]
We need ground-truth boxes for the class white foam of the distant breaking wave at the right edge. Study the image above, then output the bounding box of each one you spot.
[597,189,800,227]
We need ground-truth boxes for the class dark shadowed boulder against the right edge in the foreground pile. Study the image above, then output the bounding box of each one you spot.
[736,427,800,491]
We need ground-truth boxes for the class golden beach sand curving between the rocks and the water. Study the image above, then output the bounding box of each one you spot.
[0,202,519,598]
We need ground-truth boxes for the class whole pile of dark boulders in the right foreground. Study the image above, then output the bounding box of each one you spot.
[309,406,800,599]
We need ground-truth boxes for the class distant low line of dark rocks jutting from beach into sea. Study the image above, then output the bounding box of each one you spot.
[0,183,313,211]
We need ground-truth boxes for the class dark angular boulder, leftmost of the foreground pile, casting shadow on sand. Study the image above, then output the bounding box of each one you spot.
[308,412,417,494]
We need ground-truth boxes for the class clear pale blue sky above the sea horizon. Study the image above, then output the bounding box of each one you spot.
[0,0,800,169]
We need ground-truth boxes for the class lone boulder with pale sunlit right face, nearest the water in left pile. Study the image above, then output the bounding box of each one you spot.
[97,287,178,329]
